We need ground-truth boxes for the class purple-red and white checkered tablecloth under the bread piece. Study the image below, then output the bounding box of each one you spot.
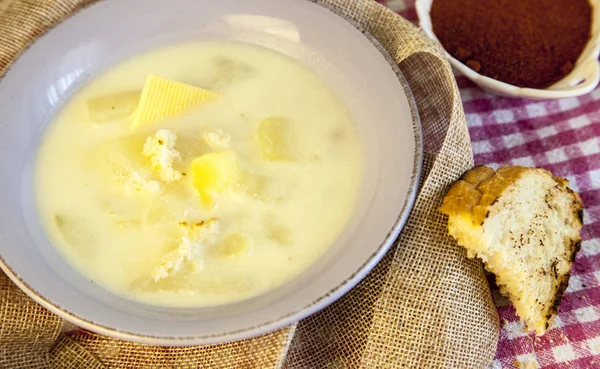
[379,0,600,369]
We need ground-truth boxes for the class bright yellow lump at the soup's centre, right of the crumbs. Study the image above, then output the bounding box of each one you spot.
[190,150,240,208]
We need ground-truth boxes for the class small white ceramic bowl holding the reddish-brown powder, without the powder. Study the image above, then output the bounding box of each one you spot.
[415,0,600,99]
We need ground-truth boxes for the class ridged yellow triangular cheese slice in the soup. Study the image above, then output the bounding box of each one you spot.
[131,74,218,129]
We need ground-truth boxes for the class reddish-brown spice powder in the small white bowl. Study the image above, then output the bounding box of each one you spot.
[431,0,592,88]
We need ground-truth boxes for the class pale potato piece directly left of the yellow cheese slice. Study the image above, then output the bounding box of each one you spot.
[87,91,140,123]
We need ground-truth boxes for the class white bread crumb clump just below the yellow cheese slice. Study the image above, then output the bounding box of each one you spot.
[142,129,181,183]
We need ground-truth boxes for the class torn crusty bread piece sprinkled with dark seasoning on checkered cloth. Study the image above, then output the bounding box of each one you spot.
[440,166,583,336]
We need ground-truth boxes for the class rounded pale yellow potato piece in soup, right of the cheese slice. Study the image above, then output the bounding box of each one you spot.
[258,117,294,161]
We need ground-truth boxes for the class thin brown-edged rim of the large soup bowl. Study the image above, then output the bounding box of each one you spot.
[0,1,423,346]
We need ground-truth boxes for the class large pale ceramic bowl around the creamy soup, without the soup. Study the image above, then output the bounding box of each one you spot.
[0,0,422,345]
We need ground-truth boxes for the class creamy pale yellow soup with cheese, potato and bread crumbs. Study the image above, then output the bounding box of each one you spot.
[35,42,364,307]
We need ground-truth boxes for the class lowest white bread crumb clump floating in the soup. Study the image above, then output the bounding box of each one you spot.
[152,218,219,282]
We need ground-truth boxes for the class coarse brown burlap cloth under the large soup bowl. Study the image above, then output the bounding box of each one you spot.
[0,0,499,369]
